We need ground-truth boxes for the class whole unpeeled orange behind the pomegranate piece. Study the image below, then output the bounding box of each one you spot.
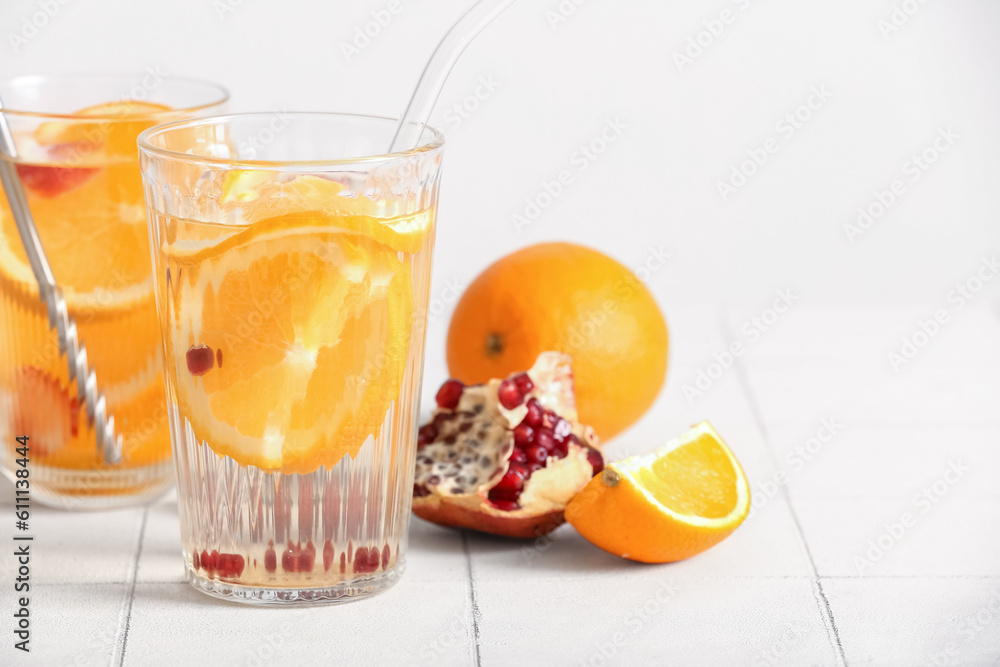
[448,243,667,439]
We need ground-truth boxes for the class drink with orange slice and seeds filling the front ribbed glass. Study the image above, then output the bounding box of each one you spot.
[152,205,433,603]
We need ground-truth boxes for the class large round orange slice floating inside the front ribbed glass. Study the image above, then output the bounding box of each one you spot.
[163,211,424,473]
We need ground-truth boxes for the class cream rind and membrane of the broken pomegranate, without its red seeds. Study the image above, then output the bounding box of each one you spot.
[413,352,600,539]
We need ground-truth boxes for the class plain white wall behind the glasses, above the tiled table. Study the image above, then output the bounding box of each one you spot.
[0,0,1000,320]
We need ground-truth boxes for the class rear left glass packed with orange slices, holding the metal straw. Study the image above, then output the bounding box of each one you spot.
[0,74,227,509]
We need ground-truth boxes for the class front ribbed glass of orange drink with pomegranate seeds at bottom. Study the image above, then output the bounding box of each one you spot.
[139,113,443,602]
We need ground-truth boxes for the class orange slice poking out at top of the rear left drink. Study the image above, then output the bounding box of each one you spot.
[35,100,171,156]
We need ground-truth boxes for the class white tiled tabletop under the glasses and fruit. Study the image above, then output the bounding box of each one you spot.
[0,300,1000,667]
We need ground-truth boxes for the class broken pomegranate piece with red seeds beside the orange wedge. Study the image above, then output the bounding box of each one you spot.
[408,352,603,540]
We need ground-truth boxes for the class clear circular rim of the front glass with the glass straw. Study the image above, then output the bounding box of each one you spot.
[137,110,444,171]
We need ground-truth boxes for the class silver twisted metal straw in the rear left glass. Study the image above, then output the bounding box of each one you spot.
[0,100,122,465]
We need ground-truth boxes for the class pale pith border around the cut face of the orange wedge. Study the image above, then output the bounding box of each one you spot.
[608,422,750,528]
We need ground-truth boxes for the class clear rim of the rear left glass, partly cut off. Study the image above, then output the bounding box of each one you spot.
[0,71,229,121]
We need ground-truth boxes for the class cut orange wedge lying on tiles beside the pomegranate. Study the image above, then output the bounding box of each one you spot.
[566,422,750,563]
